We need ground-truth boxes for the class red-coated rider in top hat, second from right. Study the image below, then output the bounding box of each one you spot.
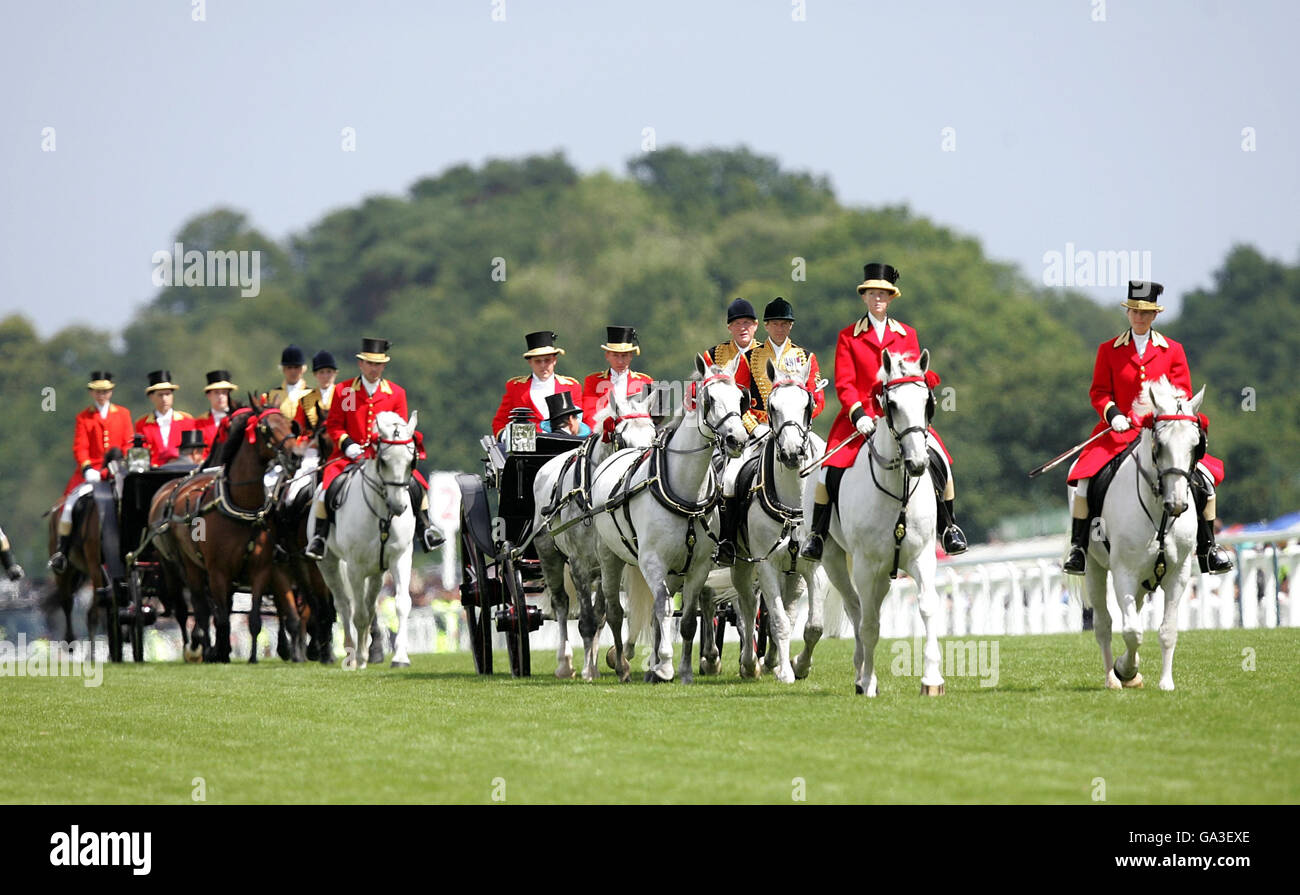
[801,263,966,559]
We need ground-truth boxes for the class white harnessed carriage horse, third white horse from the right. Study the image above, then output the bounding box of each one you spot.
[731,360,826,683]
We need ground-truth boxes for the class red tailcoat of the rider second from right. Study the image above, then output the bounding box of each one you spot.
[826,316,953,470]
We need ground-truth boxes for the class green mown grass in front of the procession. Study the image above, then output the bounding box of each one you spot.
[0,628,1300,804]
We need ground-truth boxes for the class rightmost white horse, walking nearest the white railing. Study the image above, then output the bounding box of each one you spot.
[1083,376,1205,689]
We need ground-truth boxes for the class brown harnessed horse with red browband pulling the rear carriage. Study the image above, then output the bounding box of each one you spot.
[150,408,303,662]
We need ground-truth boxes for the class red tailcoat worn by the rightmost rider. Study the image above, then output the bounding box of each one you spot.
[1069,329,1223,485]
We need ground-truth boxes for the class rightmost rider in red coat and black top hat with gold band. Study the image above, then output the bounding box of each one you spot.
[1063,280,1232,575]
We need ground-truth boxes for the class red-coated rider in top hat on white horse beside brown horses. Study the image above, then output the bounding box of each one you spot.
[307,338,442,559]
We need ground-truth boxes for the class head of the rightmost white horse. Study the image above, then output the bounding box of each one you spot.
[1132,376,1205,518]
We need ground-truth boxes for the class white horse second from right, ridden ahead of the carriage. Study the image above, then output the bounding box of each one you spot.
[803,350,944,696]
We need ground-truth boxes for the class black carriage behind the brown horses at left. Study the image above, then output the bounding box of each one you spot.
[95,459,189,662]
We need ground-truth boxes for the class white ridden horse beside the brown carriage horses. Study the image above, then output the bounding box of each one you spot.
[308,411,417,670]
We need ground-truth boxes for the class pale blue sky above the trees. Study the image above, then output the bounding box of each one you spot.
[0,0,1300,334]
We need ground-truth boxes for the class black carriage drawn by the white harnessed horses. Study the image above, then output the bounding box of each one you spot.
[458,411,582,678]
